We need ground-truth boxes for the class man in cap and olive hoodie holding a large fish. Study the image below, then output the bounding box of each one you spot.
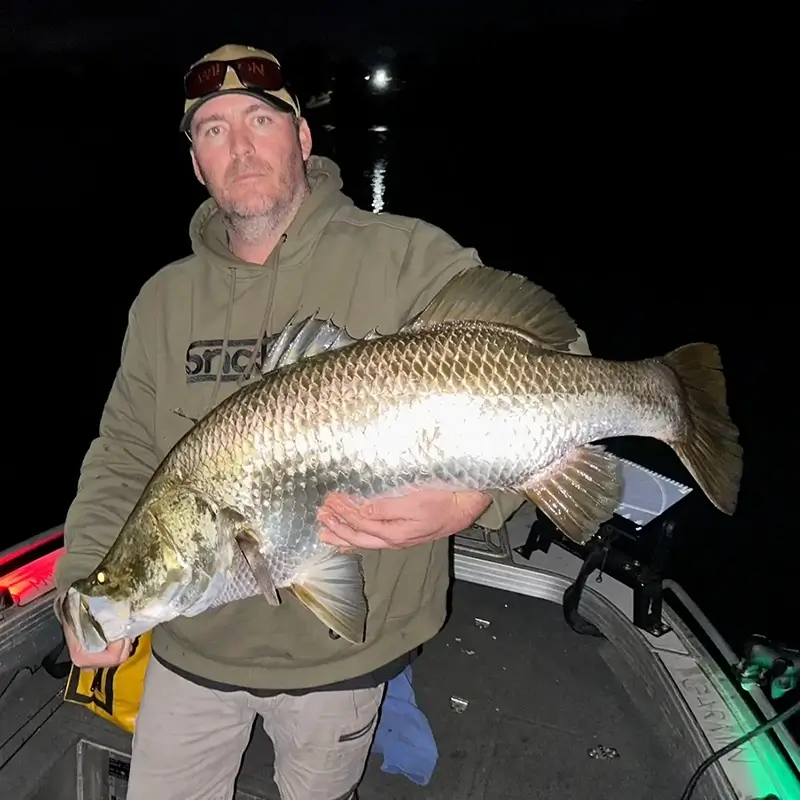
[51,45,588,800]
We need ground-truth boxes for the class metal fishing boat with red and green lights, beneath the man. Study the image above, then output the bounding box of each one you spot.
[0,459,800,800]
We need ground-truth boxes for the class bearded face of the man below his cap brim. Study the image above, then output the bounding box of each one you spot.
[191,94,311,219]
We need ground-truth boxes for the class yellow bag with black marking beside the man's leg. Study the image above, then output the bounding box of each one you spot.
[64,632,150,733]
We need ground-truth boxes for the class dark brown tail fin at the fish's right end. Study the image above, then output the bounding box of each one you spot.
[663,342,742,514]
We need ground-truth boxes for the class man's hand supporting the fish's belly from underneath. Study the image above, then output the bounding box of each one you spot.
[317,489,492,550]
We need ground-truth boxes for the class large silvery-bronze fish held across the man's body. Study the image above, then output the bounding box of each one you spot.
[62,268,742,652]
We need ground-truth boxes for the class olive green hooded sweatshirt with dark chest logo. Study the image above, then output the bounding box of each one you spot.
[56,157,582,692]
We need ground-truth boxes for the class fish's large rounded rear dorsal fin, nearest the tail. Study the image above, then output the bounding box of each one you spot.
[402,266,578,350]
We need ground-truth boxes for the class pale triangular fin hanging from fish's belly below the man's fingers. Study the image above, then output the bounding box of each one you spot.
[290,553,367,644]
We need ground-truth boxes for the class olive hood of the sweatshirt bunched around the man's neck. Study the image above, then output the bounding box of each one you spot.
[189,156,353,280]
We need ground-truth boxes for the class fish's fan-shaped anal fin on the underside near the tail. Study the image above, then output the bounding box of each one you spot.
[523,445,622,544]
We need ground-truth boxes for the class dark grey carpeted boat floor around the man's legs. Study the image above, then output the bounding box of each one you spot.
[0,581,687,800]
